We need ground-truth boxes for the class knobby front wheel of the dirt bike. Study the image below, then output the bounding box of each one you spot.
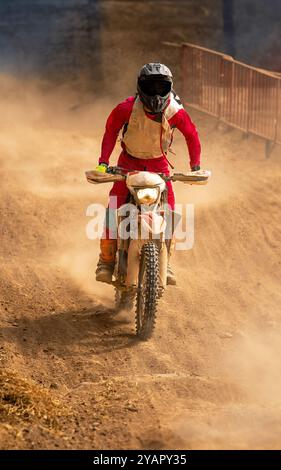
[136,242,159,340]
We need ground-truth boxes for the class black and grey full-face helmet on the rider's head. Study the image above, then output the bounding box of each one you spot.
[138,62,173,113]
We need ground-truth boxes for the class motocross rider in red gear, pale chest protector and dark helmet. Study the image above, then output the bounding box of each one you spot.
[96,63,201,284]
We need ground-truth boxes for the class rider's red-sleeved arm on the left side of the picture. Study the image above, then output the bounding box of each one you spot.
[99,96,134,164]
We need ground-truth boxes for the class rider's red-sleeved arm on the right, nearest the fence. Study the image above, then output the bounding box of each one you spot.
[169,109,201,168]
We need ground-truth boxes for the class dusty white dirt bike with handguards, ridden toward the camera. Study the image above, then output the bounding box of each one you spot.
[86,167,210,340]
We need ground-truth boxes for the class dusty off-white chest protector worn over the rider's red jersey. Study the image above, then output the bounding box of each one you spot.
[122,93,183,159]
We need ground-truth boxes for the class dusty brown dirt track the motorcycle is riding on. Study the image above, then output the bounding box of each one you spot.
[0,78,281,449]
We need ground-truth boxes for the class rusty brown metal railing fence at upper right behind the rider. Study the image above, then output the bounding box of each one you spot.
[166,43,281,152]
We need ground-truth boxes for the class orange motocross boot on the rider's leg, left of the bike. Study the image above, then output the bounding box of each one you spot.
[96,238,117,284]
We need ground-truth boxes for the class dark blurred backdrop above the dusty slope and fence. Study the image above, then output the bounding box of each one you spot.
[0,0,281,94]
